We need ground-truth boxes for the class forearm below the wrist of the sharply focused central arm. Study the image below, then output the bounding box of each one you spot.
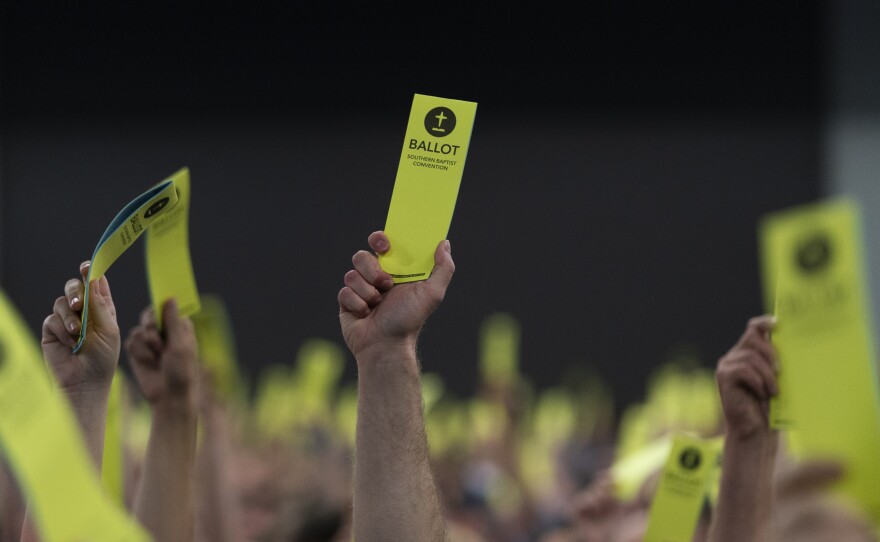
[353,347,445,542]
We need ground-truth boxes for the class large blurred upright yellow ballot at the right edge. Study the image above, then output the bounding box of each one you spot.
[760,199,880,520]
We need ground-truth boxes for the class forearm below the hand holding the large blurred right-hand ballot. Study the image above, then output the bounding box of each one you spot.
[710,431,779,542]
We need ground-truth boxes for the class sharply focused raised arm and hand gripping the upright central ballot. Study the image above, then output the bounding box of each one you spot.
[338,232,455,542]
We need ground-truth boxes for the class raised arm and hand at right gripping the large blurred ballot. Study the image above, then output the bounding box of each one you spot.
[710,316,779,542]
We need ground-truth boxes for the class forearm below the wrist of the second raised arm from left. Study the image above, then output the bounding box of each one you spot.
[134,402,197,542]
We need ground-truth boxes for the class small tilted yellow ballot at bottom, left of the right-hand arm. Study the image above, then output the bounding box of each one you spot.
[643,434,719,542]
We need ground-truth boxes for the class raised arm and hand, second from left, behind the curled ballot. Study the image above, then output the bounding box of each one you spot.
[125,299,198,542]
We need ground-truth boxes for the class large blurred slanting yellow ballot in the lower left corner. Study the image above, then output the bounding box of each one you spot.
[0,293,149,542]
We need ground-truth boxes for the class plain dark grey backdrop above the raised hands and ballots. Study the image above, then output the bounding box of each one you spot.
[0,1,829,403]
